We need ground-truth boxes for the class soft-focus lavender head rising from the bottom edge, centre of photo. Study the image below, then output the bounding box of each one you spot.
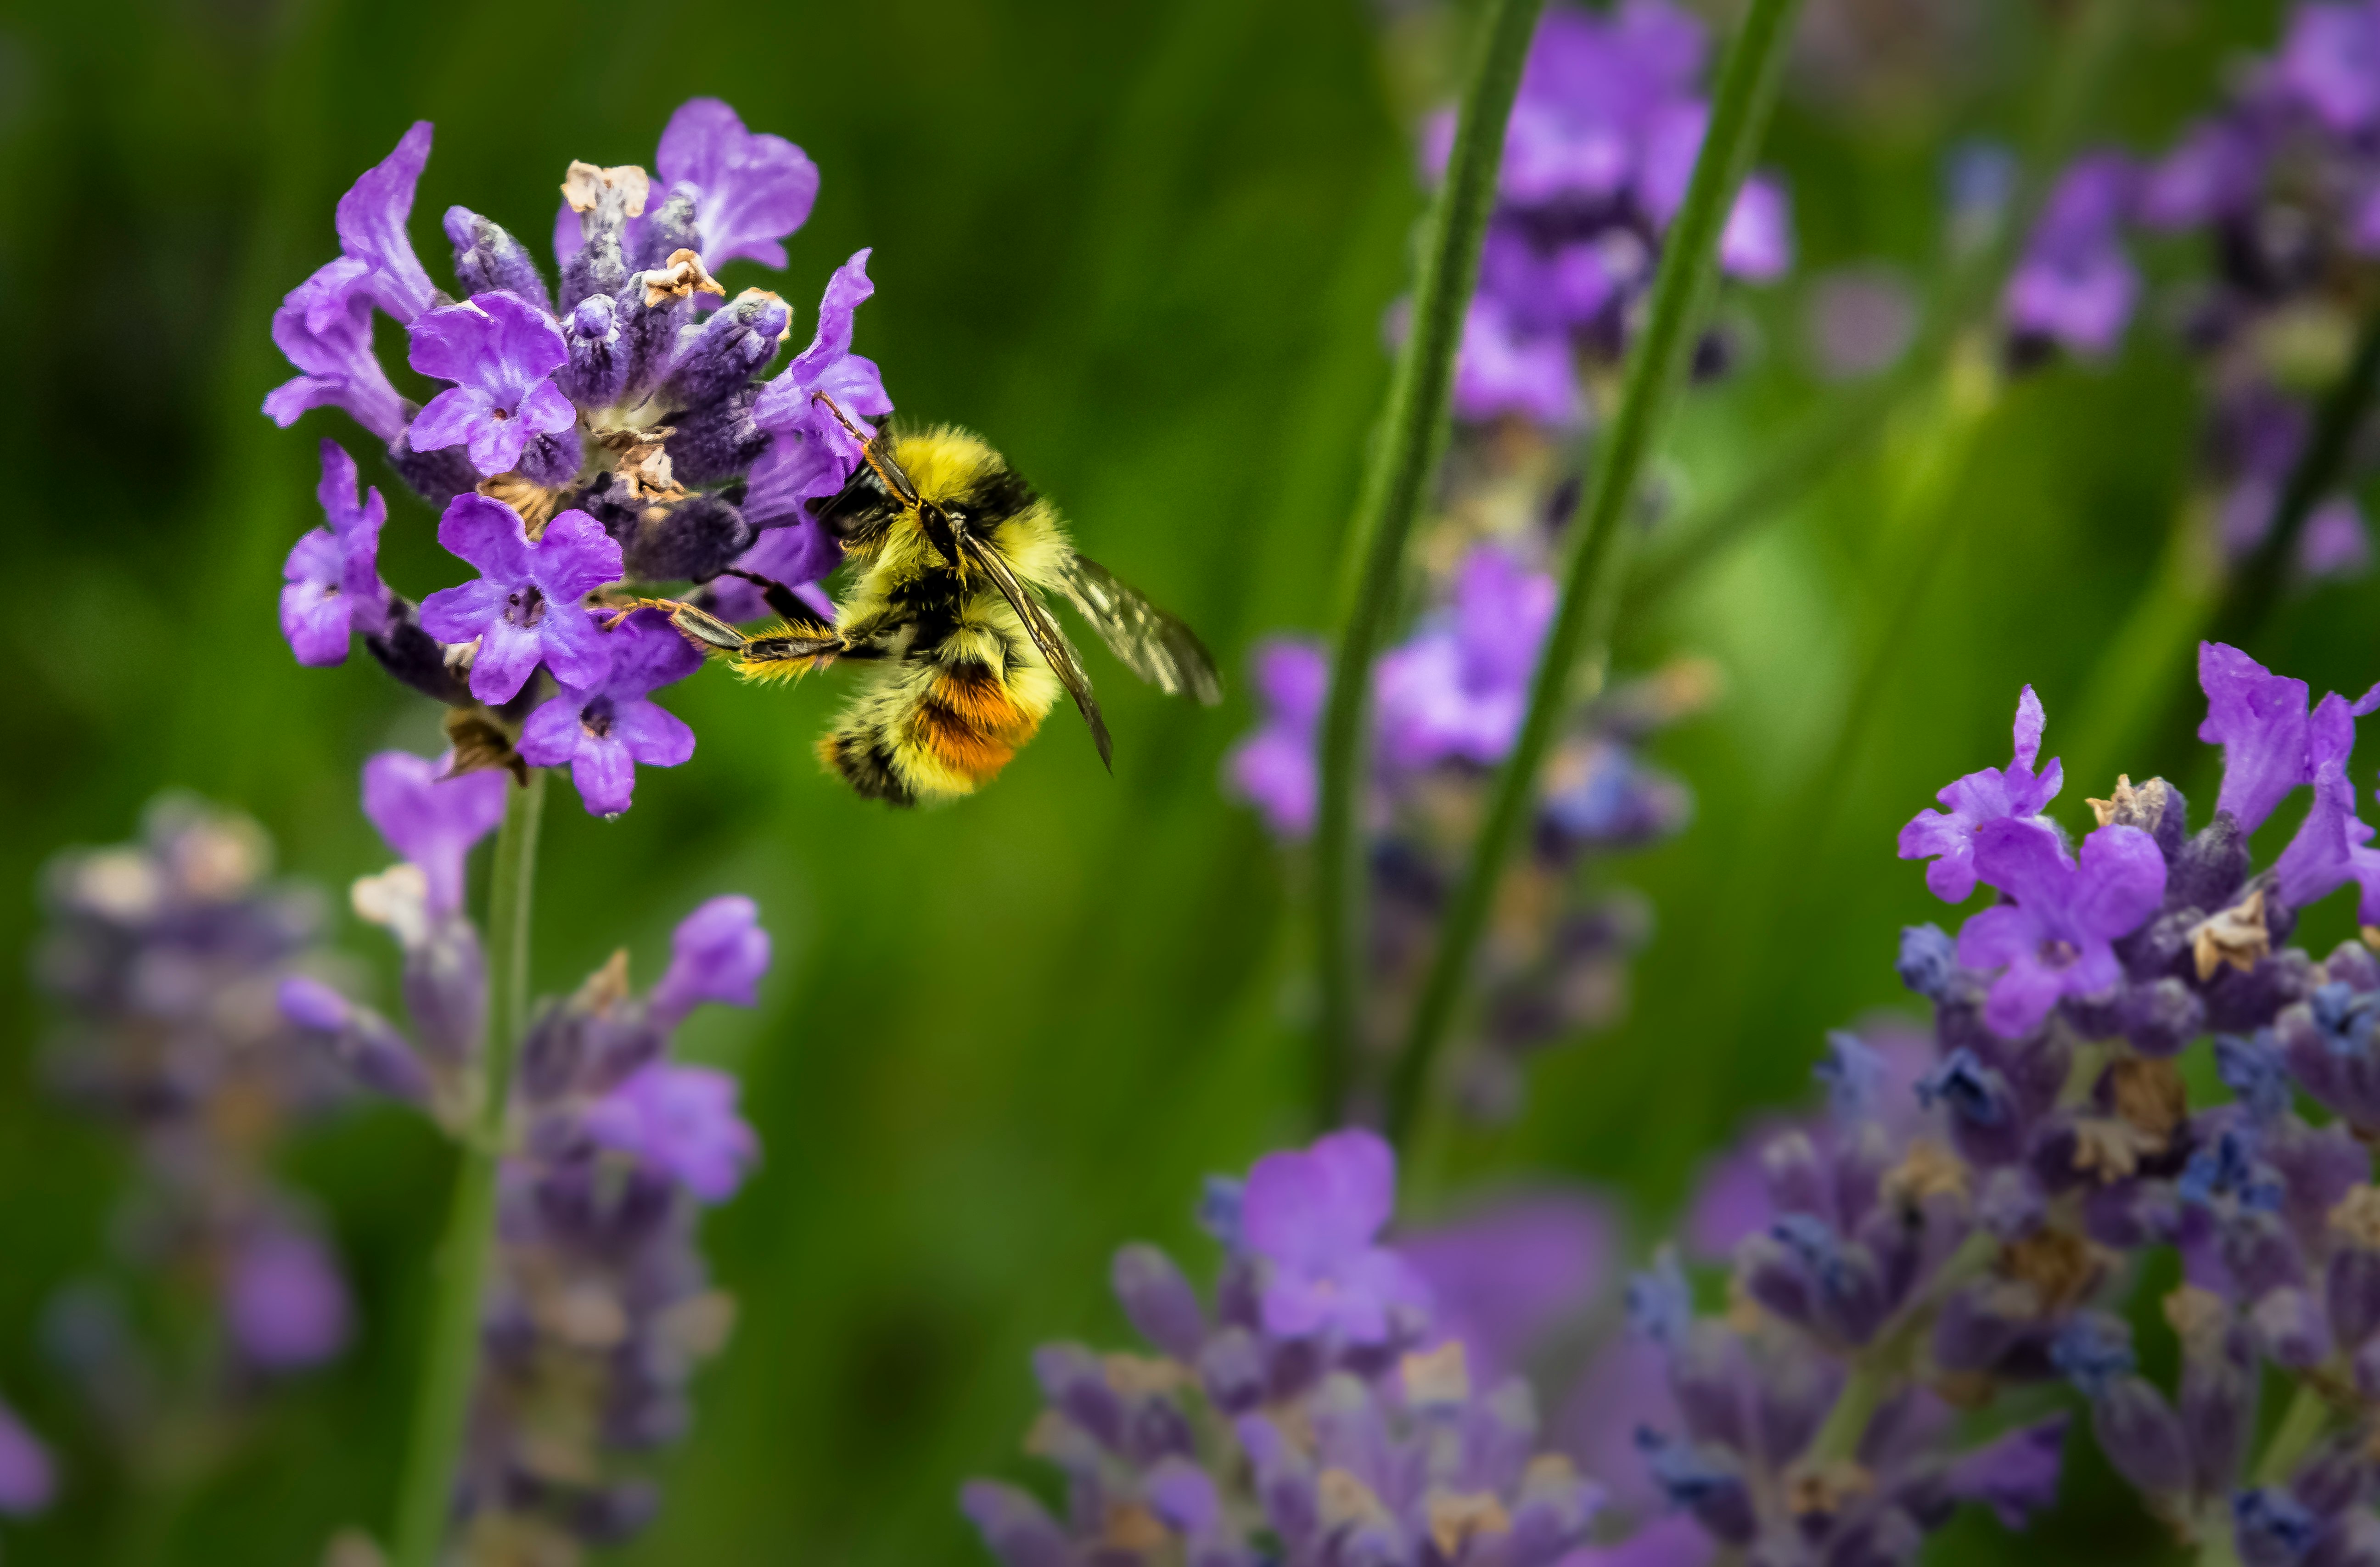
[961,1131,1602,1567]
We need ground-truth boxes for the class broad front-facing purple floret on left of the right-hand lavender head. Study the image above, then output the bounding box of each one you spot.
[1959,817,2166,1039]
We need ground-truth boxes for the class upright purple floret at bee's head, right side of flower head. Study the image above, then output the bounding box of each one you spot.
[742,250,892,528]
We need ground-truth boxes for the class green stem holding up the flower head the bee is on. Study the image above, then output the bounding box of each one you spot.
[390,769,545,1567]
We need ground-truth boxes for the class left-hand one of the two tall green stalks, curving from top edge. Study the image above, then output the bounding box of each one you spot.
[1314,0,1544,1124]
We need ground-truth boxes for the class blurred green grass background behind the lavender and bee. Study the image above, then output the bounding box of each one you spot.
[0,0,2380,1565]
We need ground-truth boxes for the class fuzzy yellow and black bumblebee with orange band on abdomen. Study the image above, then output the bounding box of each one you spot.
[643,393,1224,805]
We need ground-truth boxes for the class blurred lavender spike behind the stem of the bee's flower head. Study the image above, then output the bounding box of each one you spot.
[279,753,769,1560]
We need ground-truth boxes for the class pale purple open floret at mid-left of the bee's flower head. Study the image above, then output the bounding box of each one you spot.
[404,293,578,476]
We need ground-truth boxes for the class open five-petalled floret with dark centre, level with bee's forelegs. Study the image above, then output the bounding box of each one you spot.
[421,493,621,702]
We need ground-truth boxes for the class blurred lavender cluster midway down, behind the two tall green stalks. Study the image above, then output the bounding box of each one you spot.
[1224,540,1709,1117]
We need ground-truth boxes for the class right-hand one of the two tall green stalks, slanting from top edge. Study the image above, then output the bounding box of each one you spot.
[1380,0,1799,1143]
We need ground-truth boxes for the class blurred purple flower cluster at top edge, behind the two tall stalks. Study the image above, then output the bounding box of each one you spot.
[1423,0,1792,429]
